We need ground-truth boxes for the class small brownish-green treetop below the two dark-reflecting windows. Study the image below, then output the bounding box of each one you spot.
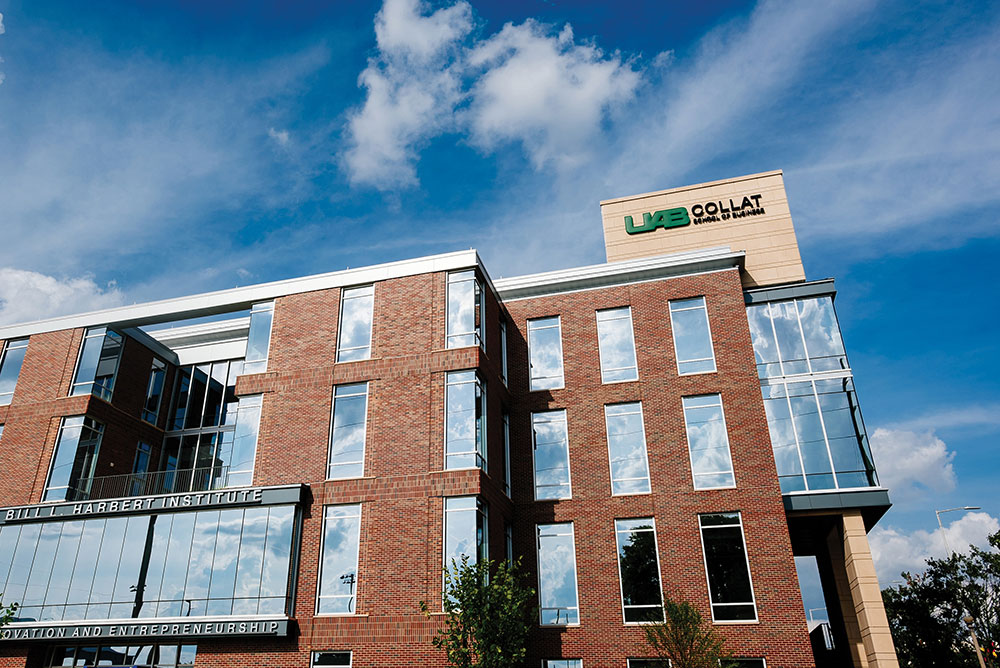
[643,599,731,668]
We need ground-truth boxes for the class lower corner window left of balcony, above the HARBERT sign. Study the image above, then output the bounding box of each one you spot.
[42,415,104,501]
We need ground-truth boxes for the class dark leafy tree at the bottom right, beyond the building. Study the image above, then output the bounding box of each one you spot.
[882,531,1000,668]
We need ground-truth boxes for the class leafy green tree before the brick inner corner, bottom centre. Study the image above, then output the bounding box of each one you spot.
[420,556,535,668]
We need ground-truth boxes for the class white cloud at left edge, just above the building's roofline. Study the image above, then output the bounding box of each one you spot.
[0,267,124,325]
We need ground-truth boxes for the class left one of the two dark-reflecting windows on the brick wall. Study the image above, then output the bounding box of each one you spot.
[615,517,663,624]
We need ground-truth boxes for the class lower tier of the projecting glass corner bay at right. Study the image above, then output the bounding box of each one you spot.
[761,377,878,492]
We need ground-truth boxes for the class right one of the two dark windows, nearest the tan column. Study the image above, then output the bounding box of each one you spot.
[698,512,757,622]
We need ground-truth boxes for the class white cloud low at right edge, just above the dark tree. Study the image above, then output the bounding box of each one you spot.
[868,512,1000,587]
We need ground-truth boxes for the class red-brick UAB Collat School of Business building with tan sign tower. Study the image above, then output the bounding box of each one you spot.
[0,172,897,668]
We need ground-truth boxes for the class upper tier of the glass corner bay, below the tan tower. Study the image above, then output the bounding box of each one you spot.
[747,295,849,378]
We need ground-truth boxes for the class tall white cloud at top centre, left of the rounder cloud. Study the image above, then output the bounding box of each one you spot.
[341,0,472,189]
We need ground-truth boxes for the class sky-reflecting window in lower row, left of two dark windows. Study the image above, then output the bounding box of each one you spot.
[538,522,580,626]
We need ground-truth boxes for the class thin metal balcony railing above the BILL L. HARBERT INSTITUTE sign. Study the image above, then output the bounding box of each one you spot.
[73,466,229,501]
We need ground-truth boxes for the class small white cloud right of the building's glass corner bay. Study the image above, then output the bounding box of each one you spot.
[871,428,957,501]
